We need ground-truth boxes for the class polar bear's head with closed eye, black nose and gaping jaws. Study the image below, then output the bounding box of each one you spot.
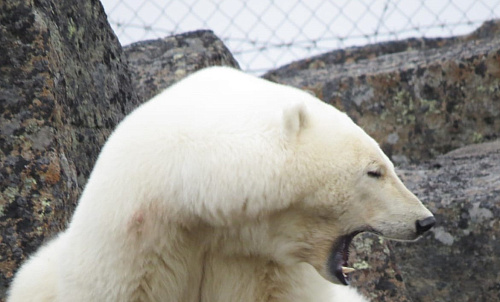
[285,102,435,284]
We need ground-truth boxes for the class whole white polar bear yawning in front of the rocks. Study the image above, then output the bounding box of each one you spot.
[8,67,435,302]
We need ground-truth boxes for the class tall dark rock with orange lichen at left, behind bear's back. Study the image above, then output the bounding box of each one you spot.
[0,0,138,300]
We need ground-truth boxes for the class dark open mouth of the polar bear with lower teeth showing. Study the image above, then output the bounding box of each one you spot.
[327,231,361,285]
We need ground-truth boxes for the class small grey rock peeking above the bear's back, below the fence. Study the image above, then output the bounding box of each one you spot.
[124,30,239,100]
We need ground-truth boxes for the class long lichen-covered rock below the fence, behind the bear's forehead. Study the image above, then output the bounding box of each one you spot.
[264,22,500,162]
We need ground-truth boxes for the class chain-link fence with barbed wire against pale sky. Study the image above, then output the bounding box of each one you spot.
[102,0,500,73]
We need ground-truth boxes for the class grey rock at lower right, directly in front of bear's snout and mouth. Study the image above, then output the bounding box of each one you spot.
[351,141,500,302]
